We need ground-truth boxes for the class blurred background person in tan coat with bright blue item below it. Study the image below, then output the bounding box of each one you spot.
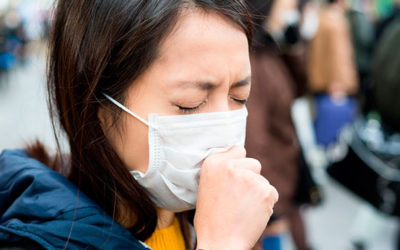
[307,0,359,148]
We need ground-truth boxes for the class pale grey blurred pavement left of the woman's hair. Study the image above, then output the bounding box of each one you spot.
[0,48,55,150]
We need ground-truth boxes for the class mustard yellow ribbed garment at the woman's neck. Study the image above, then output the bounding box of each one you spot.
[145,218,185,250]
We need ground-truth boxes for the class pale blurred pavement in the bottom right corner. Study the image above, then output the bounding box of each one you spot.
[305,171,399,250]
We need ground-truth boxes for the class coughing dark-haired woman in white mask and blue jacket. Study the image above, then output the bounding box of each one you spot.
[0,0,277,249]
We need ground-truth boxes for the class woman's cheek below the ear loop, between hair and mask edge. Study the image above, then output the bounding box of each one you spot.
[112,117,149,173]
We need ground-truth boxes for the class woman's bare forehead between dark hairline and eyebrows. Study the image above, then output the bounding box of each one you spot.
[153,9,250,79]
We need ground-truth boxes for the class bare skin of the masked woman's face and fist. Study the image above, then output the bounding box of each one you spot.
[99,9,278,249]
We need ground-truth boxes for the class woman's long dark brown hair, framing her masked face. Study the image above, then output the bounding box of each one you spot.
[29,0,252,246]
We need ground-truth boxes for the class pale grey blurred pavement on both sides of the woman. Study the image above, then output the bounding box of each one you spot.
[0,50,399,250]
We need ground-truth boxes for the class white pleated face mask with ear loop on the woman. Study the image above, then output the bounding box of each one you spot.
[105,95,247,212]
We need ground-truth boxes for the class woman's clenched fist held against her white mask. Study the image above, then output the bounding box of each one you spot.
[194,147,278,250]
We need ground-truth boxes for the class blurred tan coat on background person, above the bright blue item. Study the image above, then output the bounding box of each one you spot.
[308,0,358,96]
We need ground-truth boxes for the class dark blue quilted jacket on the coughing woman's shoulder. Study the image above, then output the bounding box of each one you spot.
[0,150,147,250]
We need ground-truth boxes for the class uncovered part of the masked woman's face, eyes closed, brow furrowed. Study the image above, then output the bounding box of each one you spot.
[104,10,251,173]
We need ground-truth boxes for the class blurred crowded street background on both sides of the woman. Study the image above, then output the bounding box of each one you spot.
[0,0,400,250]
